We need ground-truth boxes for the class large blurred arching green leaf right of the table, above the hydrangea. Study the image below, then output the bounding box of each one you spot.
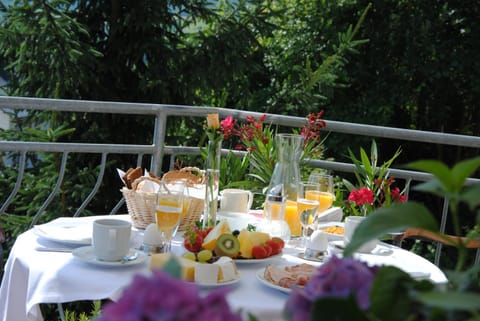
[343,201,438,256]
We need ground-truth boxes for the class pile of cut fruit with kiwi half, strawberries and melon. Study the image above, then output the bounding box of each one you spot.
[183,221,285,263]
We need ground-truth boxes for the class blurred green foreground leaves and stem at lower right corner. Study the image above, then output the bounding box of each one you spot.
[344,157,480,320]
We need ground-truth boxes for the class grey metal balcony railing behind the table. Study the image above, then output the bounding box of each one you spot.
[0,97,480,265]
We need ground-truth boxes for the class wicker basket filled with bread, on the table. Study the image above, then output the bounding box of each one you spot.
[121,167,205,231]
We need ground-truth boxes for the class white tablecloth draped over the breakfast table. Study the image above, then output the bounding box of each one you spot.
[0,215,447,321]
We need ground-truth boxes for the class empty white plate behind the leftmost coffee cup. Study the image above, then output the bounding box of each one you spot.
[33,218,92,245]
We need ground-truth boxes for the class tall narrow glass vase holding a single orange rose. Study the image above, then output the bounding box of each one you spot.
[203,139,222,228]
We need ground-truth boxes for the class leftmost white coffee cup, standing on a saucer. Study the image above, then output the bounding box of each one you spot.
[92,218,132,262]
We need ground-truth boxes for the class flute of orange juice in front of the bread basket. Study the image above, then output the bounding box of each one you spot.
[155,180,186,252]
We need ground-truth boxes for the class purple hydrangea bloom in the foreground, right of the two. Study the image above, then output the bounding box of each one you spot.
[285,256,379,321]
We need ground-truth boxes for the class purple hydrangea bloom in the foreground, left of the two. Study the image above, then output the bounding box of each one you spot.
[99,271,241,321]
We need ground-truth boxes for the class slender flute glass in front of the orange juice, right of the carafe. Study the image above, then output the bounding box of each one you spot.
[297,182,320,246]
